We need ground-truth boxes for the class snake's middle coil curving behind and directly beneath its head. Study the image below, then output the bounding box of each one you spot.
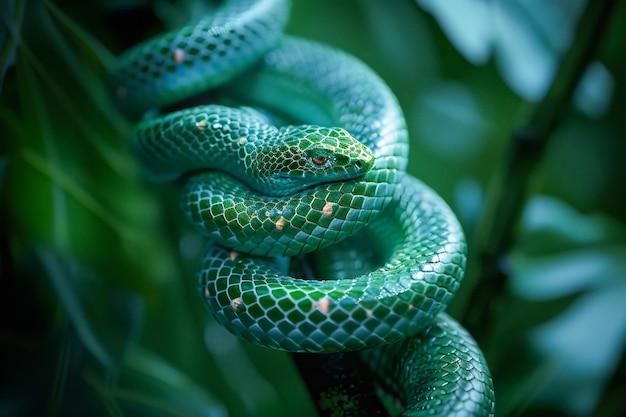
[178,37,408,256]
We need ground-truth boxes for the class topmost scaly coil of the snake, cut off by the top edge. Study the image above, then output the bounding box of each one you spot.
[108,0,289,117]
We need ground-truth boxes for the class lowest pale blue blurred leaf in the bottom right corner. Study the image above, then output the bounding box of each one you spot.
[531,284,626,416]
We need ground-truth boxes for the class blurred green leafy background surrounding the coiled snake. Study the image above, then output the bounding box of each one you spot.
[0,0,626,417]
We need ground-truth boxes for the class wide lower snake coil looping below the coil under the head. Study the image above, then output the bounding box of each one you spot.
[200,176,465,352]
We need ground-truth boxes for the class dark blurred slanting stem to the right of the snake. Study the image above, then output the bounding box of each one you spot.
[462,0,618,341]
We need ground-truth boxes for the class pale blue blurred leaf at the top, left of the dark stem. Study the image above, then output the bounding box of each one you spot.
[416,0,584,101]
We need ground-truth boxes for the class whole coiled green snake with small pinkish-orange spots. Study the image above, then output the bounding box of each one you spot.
[109,0,494,416]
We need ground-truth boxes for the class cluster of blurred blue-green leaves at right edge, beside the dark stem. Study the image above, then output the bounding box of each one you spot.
[509,197,626,416]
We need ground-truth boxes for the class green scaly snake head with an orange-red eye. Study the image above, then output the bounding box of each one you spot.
[250,126,374,195]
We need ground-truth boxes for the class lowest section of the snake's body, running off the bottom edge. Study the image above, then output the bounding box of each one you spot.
[363,313,494,417]
